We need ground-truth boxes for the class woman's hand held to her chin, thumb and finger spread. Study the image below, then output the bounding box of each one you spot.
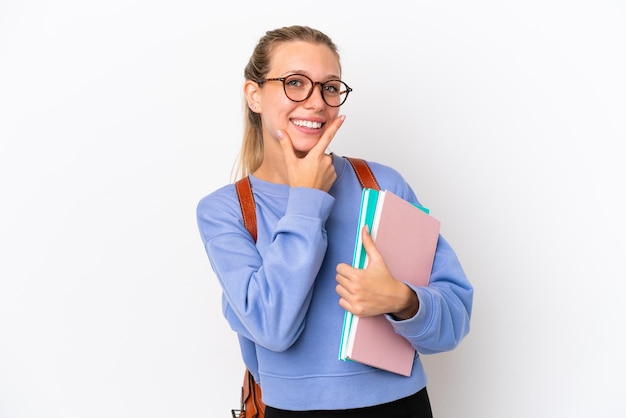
[278,115,345,192]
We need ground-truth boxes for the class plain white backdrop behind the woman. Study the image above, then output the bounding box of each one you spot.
[0,0,626,418]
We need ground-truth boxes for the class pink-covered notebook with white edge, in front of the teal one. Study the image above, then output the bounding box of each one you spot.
[345,191,440,376]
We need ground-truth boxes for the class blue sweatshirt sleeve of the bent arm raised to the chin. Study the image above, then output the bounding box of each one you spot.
[197,186,334,351]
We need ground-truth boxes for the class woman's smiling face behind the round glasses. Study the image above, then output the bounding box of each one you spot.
[257,41,341,156]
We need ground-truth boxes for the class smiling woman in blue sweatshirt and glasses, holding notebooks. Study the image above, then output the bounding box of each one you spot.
[197,26,473,418]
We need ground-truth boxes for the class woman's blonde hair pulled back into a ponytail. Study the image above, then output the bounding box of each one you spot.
[235,25,341,177]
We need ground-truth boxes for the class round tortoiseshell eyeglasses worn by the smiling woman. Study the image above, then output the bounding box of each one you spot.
[256,74,352,107]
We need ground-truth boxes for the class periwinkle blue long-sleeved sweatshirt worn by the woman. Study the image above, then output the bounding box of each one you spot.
[197,155,473,410]
